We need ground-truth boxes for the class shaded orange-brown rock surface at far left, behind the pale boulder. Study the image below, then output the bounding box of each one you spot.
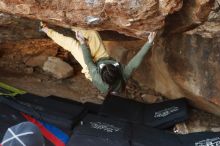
[0,39,59,72]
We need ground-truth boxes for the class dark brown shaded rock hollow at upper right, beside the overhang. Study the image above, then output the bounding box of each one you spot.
[165,0,215,34]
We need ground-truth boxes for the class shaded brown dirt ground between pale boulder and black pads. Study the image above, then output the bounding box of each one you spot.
[0,68,102,103]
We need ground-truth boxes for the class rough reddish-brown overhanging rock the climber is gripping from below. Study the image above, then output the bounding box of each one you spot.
[0,0,183,37]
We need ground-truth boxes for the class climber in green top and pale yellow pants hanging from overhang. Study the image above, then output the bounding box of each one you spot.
[41,22,156,93]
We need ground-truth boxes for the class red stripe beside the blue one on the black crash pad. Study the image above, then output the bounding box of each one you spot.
[21,113,65,146]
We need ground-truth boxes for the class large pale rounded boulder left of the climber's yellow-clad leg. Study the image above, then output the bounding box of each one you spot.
[43,57,73,79]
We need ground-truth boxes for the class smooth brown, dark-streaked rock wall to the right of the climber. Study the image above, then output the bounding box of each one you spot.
[131,1,220,115]
